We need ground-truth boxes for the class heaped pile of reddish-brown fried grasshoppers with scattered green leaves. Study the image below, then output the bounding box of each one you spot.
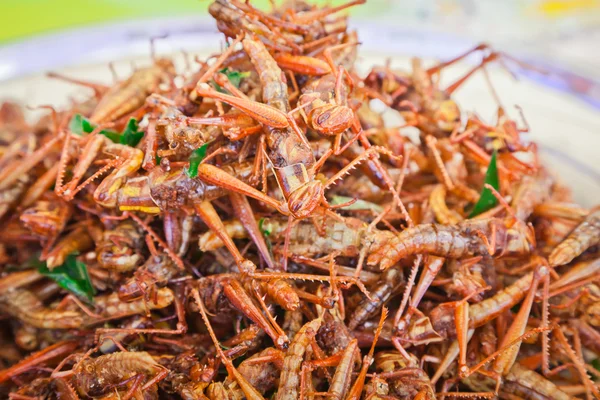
[0,0,600,400]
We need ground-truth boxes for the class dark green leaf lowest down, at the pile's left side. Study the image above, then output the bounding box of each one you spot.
[38,254,95,303]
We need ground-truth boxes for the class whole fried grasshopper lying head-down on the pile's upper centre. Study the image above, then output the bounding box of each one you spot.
[195,38,401,231]
